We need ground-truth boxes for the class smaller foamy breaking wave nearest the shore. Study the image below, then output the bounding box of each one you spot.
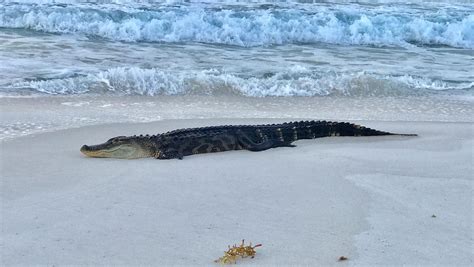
[11,66,474,97]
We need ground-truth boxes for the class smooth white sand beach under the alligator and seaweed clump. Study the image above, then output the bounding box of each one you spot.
[0,119,474,266]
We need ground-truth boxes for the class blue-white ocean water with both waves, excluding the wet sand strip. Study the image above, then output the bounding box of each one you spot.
[0,0,474,99]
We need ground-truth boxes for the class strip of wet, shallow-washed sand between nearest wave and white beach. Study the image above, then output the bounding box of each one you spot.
[0,95,474,141]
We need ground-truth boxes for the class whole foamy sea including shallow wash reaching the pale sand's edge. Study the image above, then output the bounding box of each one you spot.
[0,0,474,139]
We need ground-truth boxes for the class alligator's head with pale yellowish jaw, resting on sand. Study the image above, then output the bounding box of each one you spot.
[81,136,156,159]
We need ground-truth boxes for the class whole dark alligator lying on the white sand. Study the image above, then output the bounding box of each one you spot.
[81,121,416,159]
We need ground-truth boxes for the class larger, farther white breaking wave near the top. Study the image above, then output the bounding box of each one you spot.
[0,4,474,48]
